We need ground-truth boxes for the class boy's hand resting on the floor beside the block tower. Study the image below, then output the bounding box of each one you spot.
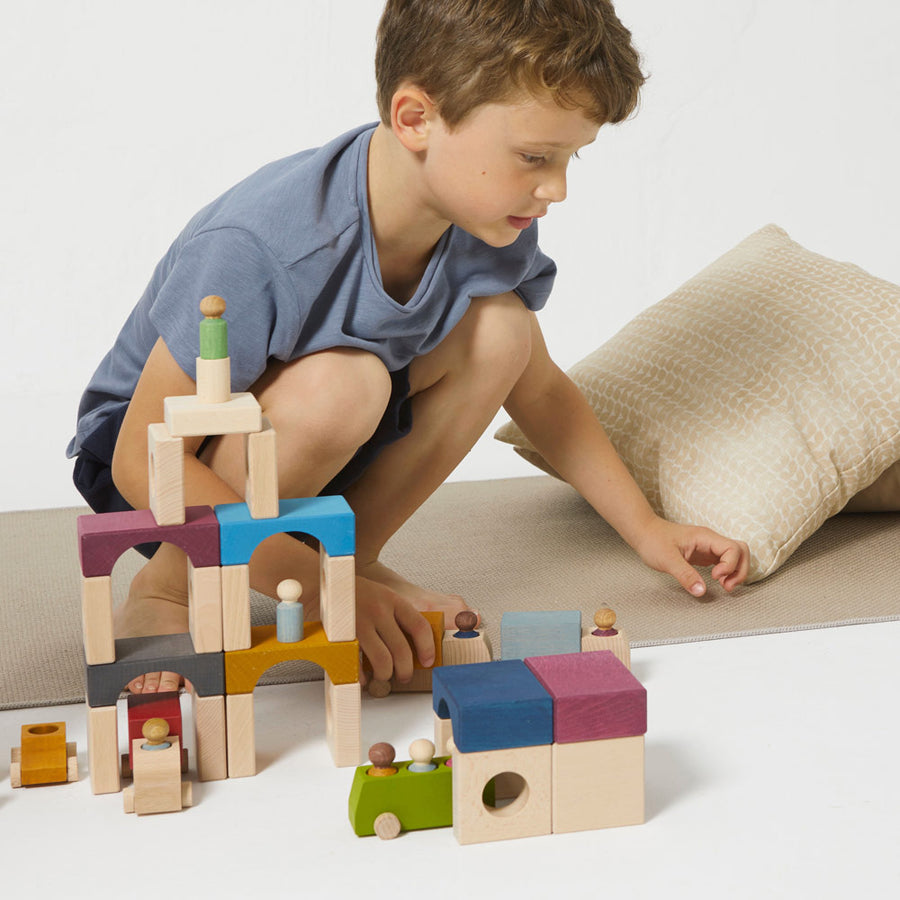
[356,578,435,681]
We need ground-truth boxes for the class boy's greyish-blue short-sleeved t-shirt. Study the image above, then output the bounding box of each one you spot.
[67,124,556,457]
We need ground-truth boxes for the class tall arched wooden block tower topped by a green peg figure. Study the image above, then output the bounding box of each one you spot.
[78,297,360,794]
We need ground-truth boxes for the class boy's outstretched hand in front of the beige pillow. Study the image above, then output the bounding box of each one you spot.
[635,518,750,597]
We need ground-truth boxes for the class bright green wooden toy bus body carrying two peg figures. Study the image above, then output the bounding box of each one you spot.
[349,756,453,836]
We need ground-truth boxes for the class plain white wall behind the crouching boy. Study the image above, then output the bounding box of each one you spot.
[0,0,900,509]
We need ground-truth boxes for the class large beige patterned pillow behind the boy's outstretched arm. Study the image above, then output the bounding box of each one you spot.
[495,225,900,581]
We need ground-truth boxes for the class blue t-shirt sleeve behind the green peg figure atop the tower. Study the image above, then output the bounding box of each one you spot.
[149,228,299,391]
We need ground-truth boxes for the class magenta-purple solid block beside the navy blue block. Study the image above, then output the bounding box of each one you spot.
[525,650,647,744]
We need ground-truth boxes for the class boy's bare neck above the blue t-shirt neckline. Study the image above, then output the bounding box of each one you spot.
[368,123,450,303]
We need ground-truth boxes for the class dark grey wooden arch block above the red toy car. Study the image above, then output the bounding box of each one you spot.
[86,633,225,707]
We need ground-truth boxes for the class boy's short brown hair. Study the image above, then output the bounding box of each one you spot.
[375,0,644,128]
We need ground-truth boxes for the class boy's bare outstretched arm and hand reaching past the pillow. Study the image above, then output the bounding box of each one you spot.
[504,315,749,596]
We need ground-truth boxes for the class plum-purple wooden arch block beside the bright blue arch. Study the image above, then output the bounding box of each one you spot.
[78,506,219,578]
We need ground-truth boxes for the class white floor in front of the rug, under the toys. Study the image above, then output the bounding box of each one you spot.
[0,622,900,900]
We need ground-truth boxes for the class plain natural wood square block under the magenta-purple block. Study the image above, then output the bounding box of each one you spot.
[553,735,644,834]
